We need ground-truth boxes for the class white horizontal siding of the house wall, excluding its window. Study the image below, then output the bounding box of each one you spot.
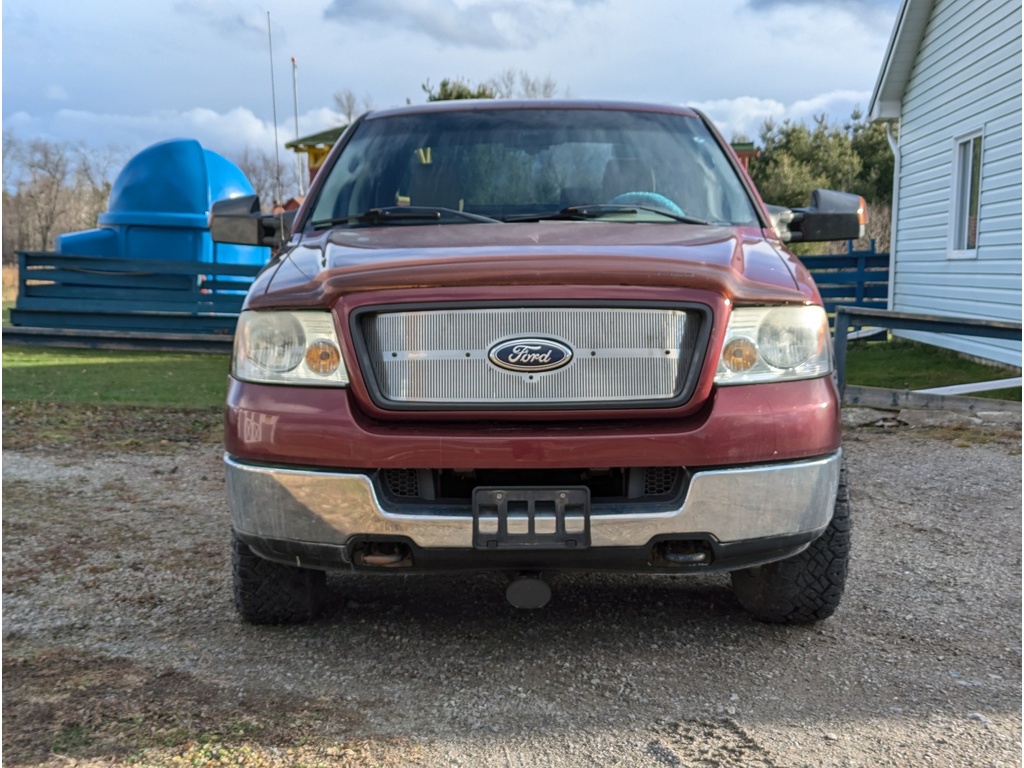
[891,0,1022,367]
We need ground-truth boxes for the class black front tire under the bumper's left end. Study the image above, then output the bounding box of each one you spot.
[231,530,327,624]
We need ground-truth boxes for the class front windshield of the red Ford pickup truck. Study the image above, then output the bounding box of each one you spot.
[309,108,757,226]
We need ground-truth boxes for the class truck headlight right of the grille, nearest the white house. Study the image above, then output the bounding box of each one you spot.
[715,306,833,385]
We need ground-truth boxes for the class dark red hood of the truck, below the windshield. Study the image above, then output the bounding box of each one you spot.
[249,221,810,307]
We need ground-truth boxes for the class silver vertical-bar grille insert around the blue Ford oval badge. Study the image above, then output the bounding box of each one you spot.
[361,307,700,407]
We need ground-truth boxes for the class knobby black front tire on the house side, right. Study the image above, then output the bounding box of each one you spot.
[732,466,850,624]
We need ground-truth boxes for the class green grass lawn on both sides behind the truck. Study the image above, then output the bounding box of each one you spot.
[3,335,1021,452]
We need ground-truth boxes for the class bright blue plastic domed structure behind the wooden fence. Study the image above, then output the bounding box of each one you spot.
[56,138,270,272]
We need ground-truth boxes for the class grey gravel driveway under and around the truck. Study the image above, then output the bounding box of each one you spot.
[3,427,1021,767]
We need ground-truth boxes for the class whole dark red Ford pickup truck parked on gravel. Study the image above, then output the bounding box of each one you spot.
[210,100,864,624]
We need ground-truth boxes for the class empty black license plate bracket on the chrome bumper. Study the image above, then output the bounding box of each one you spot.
[473,485,590,550]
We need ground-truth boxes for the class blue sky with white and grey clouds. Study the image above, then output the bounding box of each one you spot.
[2,0,899,165]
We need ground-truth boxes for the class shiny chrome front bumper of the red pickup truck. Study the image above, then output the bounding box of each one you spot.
[224,452,842,549]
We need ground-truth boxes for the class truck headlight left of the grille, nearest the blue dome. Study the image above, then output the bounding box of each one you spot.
[231,310,348,387]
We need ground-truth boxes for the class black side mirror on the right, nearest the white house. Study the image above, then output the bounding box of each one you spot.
[767,189,867,243]
